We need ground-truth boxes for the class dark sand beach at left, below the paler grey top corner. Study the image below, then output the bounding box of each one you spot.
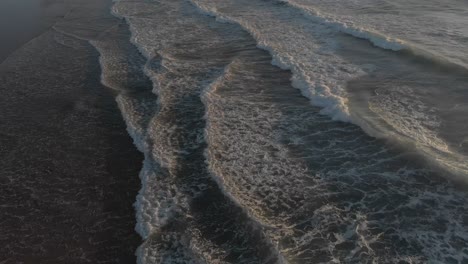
[0,0,143,264]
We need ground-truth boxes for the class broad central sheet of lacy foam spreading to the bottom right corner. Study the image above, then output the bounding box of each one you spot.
[196,41,466,263]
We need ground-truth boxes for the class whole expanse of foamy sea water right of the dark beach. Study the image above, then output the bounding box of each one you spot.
[83,0,468,263]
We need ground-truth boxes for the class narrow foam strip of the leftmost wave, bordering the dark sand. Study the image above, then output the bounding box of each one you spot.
[113,1,288,263]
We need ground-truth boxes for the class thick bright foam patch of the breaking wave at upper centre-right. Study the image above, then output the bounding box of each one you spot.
[191,0,362,122]
